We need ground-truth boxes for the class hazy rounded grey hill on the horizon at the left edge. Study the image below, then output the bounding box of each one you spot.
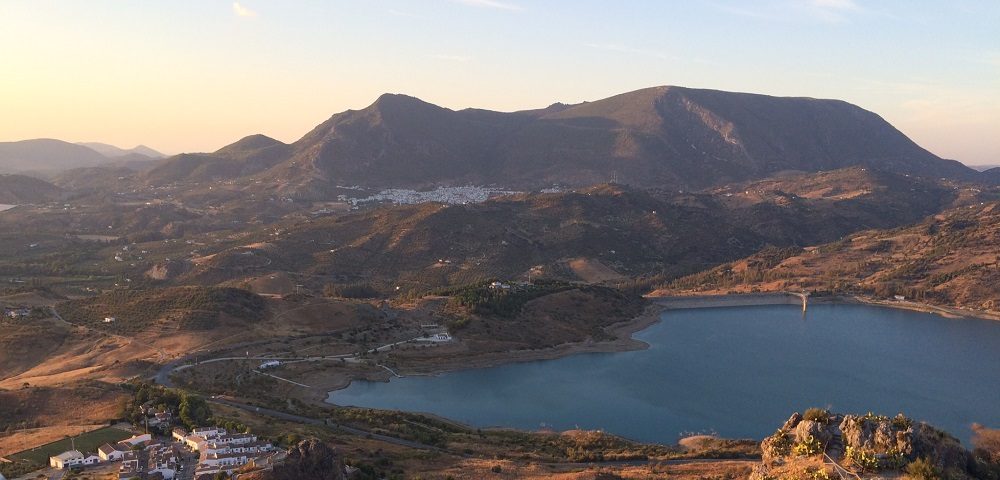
[0,138,108,173]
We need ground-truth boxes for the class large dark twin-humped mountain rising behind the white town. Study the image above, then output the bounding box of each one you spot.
[227,87,985,197]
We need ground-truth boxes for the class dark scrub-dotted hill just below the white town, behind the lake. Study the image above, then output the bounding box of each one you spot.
[179,187,767,289]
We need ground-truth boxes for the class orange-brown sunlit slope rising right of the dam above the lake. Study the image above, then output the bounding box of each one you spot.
[658,202,1000,313]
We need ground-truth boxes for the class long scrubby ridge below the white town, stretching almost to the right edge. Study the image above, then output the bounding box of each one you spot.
[177,169,985,291]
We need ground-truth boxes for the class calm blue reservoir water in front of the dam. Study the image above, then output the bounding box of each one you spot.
[328,305,1000,444]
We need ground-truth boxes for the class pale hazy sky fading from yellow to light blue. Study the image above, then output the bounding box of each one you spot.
[0,0,1000,164]
